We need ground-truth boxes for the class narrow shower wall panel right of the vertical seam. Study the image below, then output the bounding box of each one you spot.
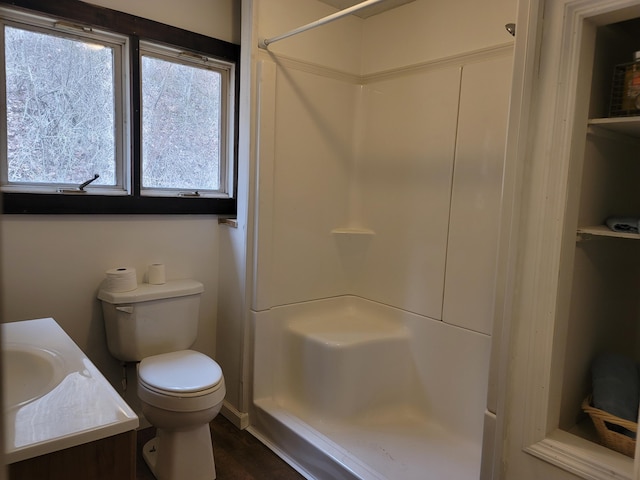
[443,52,512,335]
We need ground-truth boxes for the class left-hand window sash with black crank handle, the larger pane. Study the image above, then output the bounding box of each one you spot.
[2,23,127,193]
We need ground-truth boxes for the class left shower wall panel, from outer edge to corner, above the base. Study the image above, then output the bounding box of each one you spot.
[254,62,358,310]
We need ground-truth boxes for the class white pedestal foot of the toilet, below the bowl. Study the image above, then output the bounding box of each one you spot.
[142,424,216,480]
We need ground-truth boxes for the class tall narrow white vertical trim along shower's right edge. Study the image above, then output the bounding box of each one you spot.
[482,0,543,480]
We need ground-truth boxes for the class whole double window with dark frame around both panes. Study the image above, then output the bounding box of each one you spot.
[0,0,239,214]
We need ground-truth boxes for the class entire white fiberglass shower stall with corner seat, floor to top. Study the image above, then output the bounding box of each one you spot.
[245,0,515,480]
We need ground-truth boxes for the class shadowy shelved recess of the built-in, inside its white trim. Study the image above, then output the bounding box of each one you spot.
[559,13,640,478]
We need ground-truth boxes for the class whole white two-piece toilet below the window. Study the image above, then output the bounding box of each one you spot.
[98,280,226,480]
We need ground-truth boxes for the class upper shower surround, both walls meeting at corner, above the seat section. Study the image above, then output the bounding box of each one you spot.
[254,51,511,322]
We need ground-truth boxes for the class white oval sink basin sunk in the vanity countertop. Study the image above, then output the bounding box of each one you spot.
[2,343,64,409]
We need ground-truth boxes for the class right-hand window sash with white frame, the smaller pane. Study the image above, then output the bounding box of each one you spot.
[140,43,229,194]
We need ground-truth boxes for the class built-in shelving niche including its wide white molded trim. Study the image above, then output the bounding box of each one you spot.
[498,0,640,480]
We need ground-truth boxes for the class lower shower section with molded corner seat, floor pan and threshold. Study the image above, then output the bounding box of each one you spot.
[250,296,490,480]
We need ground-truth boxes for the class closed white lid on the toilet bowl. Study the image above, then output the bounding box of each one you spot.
[138,350,222,394]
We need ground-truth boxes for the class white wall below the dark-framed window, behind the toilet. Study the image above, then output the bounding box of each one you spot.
[2,215,219,410]
